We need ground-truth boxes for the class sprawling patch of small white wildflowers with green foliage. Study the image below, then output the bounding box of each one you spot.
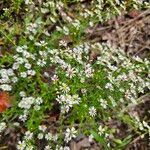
[0,0,150,150]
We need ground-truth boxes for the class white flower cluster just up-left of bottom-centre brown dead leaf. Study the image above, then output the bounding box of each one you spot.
[64,127,77,143]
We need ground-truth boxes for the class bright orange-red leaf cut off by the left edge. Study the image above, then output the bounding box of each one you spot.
[0,92,11,113]
